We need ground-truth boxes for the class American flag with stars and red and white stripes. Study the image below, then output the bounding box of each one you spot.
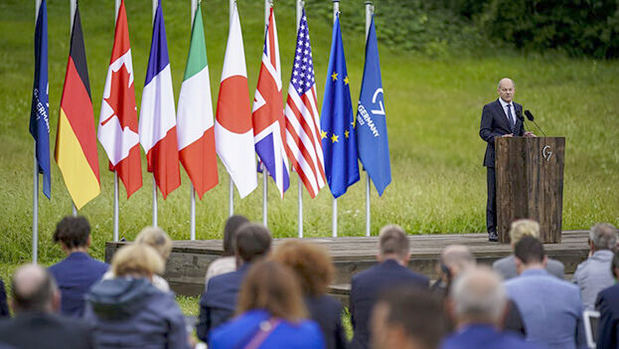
[285,9,325,198]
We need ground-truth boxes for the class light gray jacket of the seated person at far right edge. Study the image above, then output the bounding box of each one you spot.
[573,250,615,309]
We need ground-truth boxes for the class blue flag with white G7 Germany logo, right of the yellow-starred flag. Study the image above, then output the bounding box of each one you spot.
[356,16,391,195]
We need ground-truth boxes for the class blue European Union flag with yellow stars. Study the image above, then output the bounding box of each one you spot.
[320,16,359,198]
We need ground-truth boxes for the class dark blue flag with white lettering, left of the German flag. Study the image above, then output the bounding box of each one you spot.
[30,0,51,199]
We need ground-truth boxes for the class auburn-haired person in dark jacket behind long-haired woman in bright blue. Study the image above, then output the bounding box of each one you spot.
[273,240,347,349]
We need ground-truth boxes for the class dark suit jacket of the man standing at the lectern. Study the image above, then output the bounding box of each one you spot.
[479,99,524,167]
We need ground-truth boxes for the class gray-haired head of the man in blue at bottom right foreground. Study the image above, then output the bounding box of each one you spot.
[450,266,507,324]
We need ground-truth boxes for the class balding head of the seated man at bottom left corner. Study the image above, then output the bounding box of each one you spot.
[11,264,58,313]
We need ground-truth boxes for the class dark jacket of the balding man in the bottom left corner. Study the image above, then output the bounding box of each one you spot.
[0,313,94,349]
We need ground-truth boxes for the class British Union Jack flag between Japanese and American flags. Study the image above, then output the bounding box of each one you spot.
[252,8,290,197]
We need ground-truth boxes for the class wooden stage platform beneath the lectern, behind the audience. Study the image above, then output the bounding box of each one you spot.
[105,231,588,296]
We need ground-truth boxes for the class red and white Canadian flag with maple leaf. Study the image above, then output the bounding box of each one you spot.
[97,0,142,198]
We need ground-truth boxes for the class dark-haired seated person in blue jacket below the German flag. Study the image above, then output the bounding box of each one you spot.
[49,216,108,317]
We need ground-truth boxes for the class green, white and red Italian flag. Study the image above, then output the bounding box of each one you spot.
[177,3,219,199]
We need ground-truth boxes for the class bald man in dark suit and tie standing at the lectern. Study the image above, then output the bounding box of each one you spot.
[479,78,535,241]
